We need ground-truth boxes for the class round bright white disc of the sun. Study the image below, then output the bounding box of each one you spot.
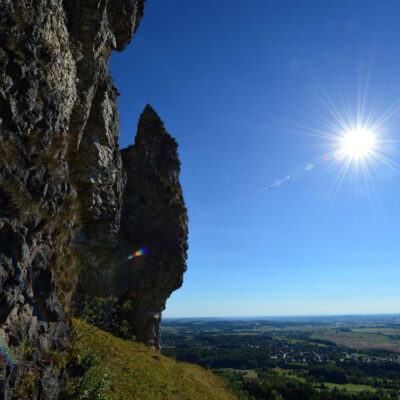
[339,127,377,161]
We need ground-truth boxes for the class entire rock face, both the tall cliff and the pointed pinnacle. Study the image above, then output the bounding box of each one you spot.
[0,0,186,399]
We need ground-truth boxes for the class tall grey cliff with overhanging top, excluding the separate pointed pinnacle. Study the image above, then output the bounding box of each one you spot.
[0,0,158,399]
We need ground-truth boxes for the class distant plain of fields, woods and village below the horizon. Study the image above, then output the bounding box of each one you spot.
[162,316,400,400]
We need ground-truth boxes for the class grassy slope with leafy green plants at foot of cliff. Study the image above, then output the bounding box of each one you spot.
[69,320,235,400]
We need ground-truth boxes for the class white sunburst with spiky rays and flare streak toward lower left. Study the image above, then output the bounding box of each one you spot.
[260,101,400,194]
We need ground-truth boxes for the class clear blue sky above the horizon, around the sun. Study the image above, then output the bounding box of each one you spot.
[111,0,400,317]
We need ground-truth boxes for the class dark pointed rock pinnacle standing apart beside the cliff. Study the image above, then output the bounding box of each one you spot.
[116,105,188,349]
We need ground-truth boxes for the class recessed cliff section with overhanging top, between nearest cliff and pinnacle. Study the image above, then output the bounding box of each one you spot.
[66,0,144,305]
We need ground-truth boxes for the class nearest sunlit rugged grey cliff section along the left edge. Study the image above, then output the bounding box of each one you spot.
[0,0,77,399]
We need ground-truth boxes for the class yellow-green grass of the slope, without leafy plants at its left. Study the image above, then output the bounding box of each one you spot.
[73,322,235,400]
